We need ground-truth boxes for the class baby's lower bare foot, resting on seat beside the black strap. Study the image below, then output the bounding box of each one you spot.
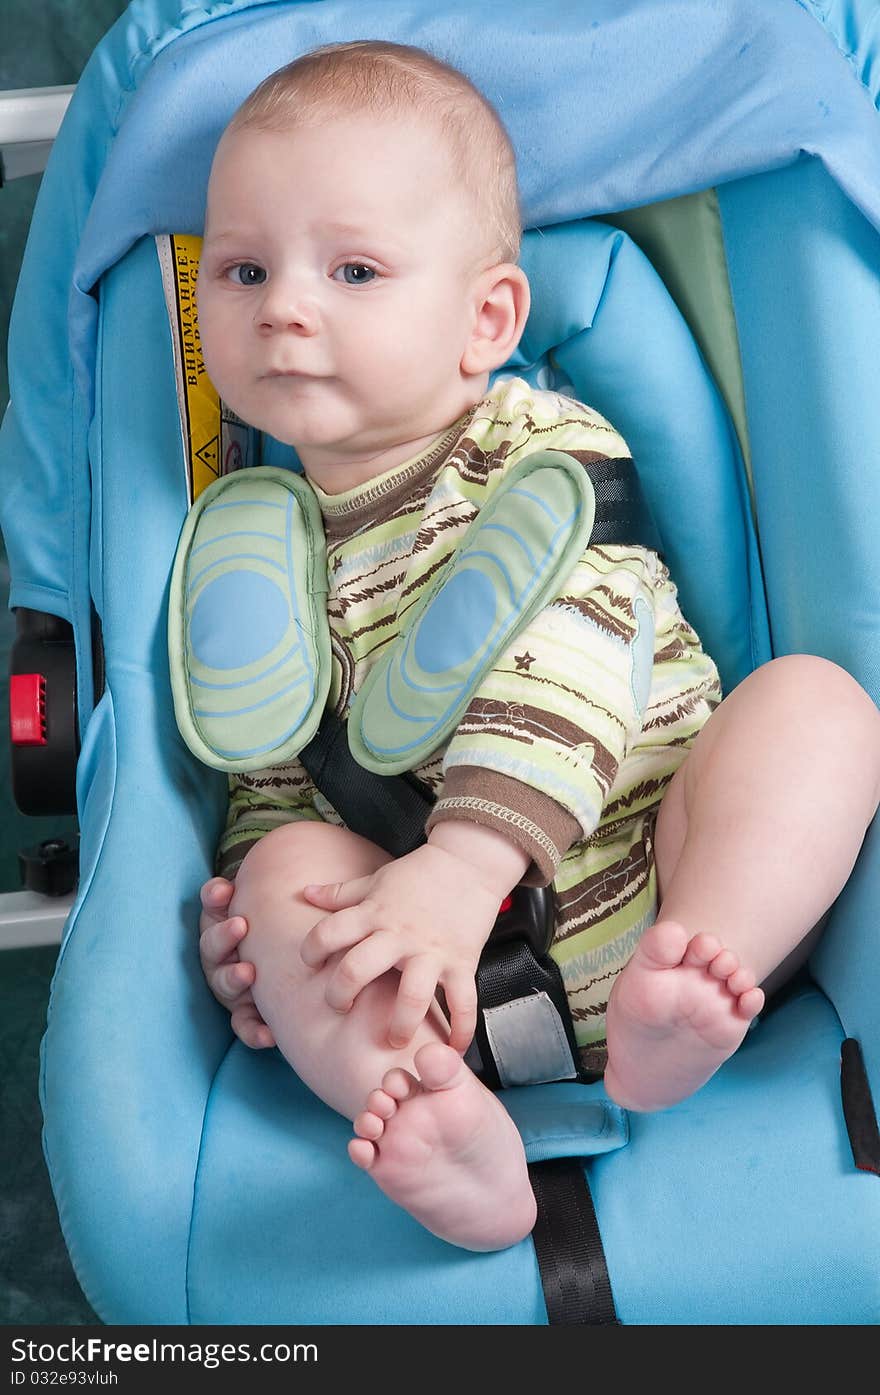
[349,1042,536,1250]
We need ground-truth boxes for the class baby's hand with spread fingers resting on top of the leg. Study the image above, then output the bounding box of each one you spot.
[300,844,501,1052]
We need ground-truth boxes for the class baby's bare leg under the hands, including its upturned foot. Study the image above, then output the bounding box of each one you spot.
[229,822,536,1250]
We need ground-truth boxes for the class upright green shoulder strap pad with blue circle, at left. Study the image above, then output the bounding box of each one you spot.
[169,466,331,770]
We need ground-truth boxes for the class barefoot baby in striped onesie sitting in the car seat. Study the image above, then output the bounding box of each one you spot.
[192,42,880,1250]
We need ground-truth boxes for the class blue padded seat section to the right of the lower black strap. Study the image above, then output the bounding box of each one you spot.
[590,988,880,1325]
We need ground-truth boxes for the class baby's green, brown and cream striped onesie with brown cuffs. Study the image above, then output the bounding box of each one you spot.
[216,378,721,1071]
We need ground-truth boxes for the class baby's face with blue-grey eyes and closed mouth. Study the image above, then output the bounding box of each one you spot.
[198,116,493,488]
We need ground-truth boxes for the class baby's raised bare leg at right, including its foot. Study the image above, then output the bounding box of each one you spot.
[605,656,880,1109]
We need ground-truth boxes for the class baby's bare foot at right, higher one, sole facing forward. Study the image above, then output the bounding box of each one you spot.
[605,921,764,1110]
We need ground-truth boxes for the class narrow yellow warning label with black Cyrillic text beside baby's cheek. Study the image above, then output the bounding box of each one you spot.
[170,233,222,499]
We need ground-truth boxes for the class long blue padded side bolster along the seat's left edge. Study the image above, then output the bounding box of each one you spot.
[40,239,229,1322]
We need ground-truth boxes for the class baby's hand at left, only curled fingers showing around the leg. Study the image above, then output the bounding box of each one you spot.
[198,876,275,1048]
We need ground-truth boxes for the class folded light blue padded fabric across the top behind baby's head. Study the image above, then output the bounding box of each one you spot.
[70,0,880,286]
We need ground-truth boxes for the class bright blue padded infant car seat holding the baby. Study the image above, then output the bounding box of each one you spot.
[0,0,880,1324]
